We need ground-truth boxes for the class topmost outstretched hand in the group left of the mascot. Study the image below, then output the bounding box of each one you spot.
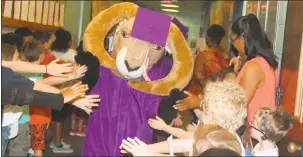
[46,59,74,77]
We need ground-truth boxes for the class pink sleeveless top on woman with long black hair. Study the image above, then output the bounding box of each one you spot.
[236,57,277,122]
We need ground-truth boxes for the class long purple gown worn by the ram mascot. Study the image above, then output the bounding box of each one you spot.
[82,56,173,156]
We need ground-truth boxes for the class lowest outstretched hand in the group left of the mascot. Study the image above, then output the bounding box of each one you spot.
[72,95,100,114]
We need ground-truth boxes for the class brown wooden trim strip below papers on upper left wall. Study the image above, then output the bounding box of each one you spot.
[1,16,63,31]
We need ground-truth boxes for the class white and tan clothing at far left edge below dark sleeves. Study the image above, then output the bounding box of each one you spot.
[2,105,23,139]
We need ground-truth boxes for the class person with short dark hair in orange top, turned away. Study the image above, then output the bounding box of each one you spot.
[189,24,229,94]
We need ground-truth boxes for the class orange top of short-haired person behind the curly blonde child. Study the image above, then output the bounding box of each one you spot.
[189,49,230,94]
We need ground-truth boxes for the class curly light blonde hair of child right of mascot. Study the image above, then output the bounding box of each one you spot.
[202,81,247,133]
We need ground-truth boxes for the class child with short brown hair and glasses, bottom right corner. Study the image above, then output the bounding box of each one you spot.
[249,108,292,156]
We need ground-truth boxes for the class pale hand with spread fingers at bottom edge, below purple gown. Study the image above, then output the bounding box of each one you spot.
[120,137,154,156]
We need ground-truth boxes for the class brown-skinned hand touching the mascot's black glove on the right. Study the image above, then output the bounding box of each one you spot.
[174,91,202,111]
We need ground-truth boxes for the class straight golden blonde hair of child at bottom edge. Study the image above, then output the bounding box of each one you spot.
[193,125,241,156]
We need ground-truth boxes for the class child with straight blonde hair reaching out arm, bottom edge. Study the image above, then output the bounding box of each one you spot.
[120,125,241,156]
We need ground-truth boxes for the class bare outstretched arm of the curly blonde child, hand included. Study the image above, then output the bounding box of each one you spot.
[148,116,193,139]
